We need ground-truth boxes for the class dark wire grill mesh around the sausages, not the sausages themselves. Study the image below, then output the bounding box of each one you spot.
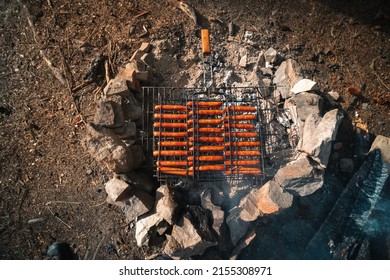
[141,86,296,184]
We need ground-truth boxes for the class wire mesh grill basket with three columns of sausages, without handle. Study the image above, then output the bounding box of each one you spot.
[142,87,294,185]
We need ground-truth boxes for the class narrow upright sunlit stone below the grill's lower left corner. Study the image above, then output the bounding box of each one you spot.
[156,185,178,225]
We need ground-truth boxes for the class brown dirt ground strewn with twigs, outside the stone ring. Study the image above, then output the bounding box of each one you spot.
[0,0,390,259]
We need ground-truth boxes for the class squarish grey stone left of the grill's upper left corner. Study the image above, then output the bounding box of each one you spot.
[94,100,124,128]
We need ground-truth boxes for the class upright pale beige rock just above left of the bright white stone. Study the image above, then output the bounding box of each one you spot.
[273,59,302,99]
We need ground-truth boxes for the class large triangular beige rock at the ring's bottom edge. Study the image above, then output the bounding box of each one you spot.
[164,217,216,259]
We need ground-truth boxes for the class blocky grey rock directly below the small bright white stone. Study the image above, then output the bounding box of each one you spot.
[291,92,323,121]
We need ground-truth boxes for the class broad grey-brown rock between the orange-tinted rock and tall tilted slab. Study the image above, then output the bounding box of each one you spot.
[274,156,324,196]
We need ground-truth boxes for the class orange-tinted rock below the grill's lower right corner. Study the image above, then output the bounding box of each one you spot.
[256,181,293,214]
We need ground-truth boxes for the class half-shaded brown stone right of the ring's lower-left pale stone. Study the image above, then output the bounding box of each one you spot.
[124,190,154,223]
